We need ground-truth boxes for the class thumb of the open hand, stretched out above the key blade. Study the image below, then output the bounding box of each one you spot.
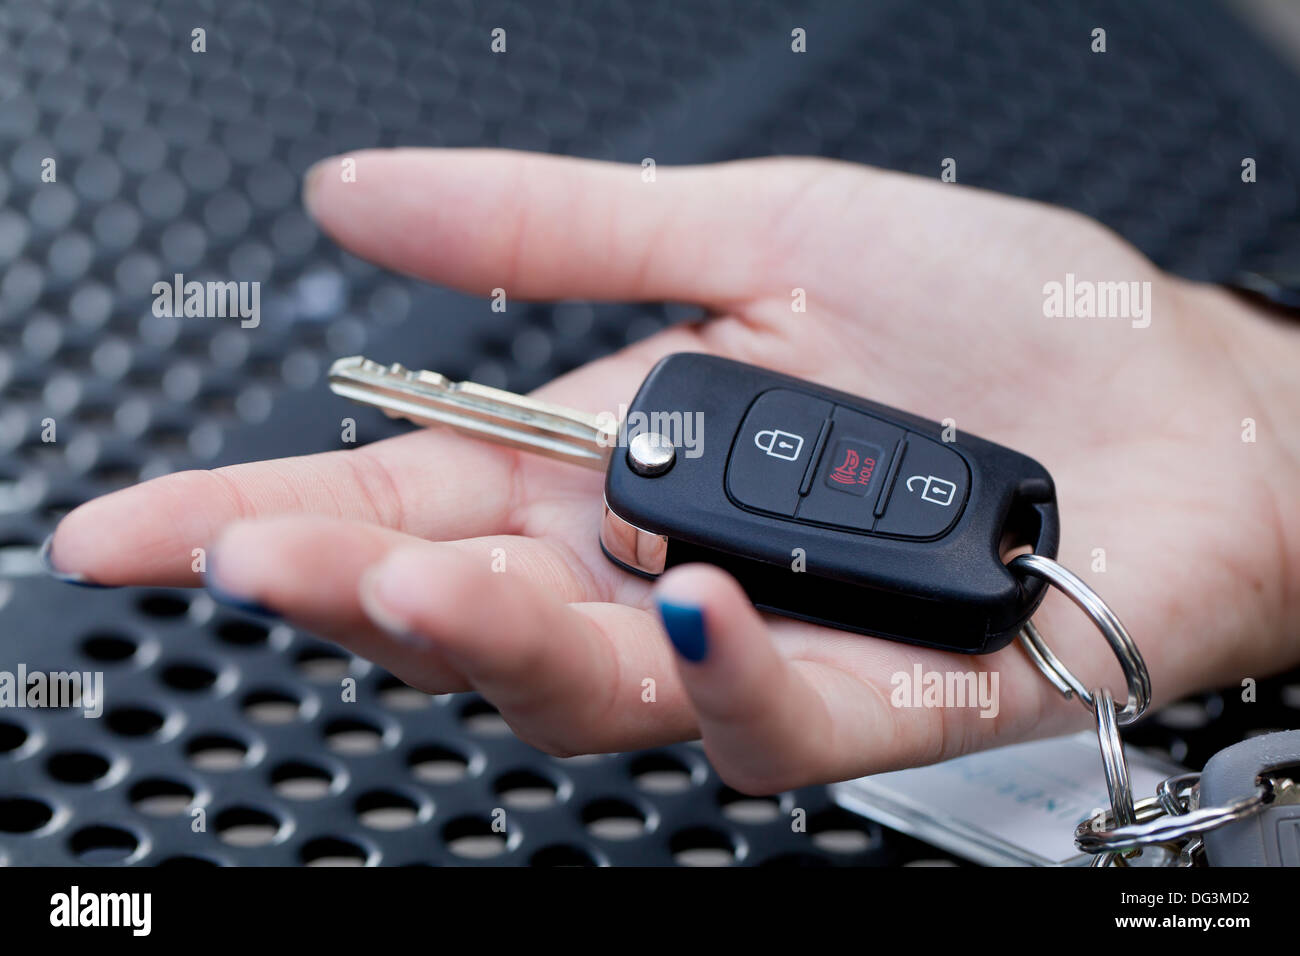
[304,148,814,306]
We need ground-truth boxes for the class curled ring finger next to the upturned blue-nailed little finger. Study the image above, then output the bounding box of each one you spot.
[361,545,694,754]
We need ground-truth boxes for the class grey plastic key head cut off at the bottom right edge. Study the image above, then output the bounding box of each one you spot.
[1200,730,1300,866]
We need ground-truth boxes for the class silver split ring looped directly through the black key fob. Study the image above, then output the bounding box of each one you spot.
[1008,554,1151,724]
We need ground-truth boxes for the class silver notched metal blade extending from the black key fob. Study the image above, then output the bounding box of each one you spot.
[329,355,619,471]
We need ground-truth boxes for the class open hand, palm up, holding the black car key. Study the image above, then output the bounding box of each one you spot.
[52,150,1300,793]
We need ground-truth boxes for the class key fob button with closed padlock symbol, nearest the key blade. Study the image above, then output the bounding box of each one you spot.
[727,389,835,518]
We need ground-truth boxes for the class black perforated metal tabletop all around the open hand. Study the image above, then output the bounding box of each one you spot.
[0,0,1300,865]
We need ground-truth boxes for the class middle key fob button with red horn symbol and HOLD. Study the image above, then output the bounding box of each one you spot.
[797,405,904,531]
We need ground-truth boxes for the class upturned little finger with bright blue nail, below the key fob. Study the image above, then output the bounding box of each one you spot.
[655,564,844,795]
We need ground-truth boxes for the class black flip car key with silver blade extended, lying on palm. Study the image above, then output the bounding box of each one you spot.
[330,352,1060,653]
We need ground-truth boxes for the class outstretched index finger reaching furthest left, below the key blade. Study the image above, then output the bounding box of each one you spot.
[48,429,529,587]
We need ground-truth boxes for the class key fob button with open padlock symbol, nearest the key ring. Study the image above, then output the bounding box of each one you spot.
[876,434,970,537]
